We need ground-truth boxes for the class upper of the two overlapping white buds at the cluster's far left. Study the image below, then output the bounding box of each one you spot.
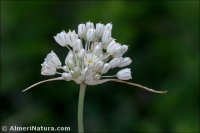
[44,51,61,67]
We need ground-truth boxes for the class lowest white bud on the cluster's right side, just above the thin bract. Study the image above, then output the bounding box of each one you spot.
[117,68,132,80]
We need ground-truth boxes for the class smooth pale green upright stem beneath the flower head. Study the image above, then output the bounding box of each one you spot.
[78,84,86,133]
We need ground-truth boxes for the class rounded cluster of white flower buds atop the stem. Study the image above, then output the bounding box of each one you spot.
[41,22,132,85]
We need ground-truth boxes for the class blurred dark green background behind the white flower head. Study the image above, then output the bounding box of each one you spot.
[0,0,200,133]
